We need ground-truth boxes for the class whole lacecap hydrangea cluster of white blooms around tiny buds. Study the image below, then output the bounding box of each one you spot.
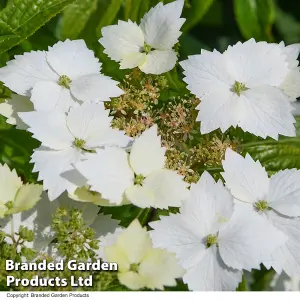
[0,0,300,291]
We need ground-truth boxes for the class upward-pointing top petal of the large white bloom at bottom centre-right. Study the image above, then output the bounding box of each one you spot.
[180,172,233,238]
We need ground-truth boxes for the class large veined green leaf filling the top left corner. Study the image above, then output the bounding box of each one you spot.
[0,0,74,54]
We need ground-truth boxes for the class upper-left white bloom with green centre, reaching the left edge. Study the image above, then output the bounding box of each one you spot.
[0,40,123,111]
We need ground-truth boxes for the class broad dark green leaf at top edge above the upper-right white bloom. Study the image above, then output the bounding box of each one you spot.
[234,0,275,41]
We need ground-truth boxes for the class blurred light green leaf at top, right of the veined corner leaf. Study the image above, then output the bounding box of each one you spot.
[58,0,98,40]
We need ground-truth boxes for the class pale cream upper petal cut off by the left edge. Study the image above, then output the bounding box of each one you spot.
[0,164,22,204]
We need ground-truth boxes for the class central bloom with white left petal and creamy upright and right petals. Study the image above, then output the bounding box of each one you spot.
[75,125,188,208]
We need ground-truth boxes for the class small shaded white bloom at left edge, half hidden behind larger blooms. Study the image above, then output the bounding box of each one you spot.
[0,94,34,129]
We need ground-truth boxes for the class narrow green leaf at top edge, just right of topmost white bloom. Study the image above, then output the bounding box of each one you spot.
[182,0,214,32]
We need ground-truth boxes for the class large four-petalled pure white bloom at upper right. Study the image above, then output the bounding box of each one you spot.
[181,39,295,139]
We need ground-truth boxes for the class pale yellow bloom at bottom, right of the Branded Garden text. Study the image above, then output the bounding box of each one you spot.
[100,220,184,290]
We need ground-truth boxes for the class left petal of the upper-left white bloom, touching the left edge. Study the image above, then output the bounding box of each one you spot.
[0,51,59,96]
